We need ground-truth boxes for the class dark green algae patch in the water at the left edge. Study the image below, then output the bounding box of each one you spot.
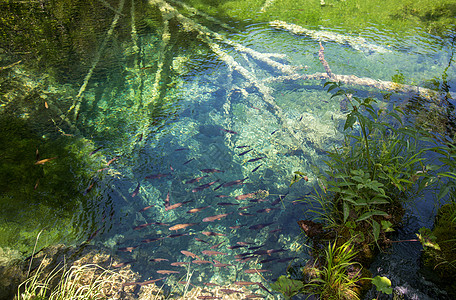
[0,114,103,254]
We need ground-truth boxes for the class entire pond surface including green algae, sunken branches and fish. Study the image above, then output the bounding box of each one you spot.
[0,0,456,299]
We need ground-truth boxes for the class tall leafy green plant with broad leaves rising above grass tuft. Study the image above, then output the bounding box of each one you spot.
[295,82,437,244]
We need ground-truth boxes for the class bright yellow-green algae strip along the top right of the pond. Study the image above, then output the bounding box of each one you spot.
[185,0,456,34]
